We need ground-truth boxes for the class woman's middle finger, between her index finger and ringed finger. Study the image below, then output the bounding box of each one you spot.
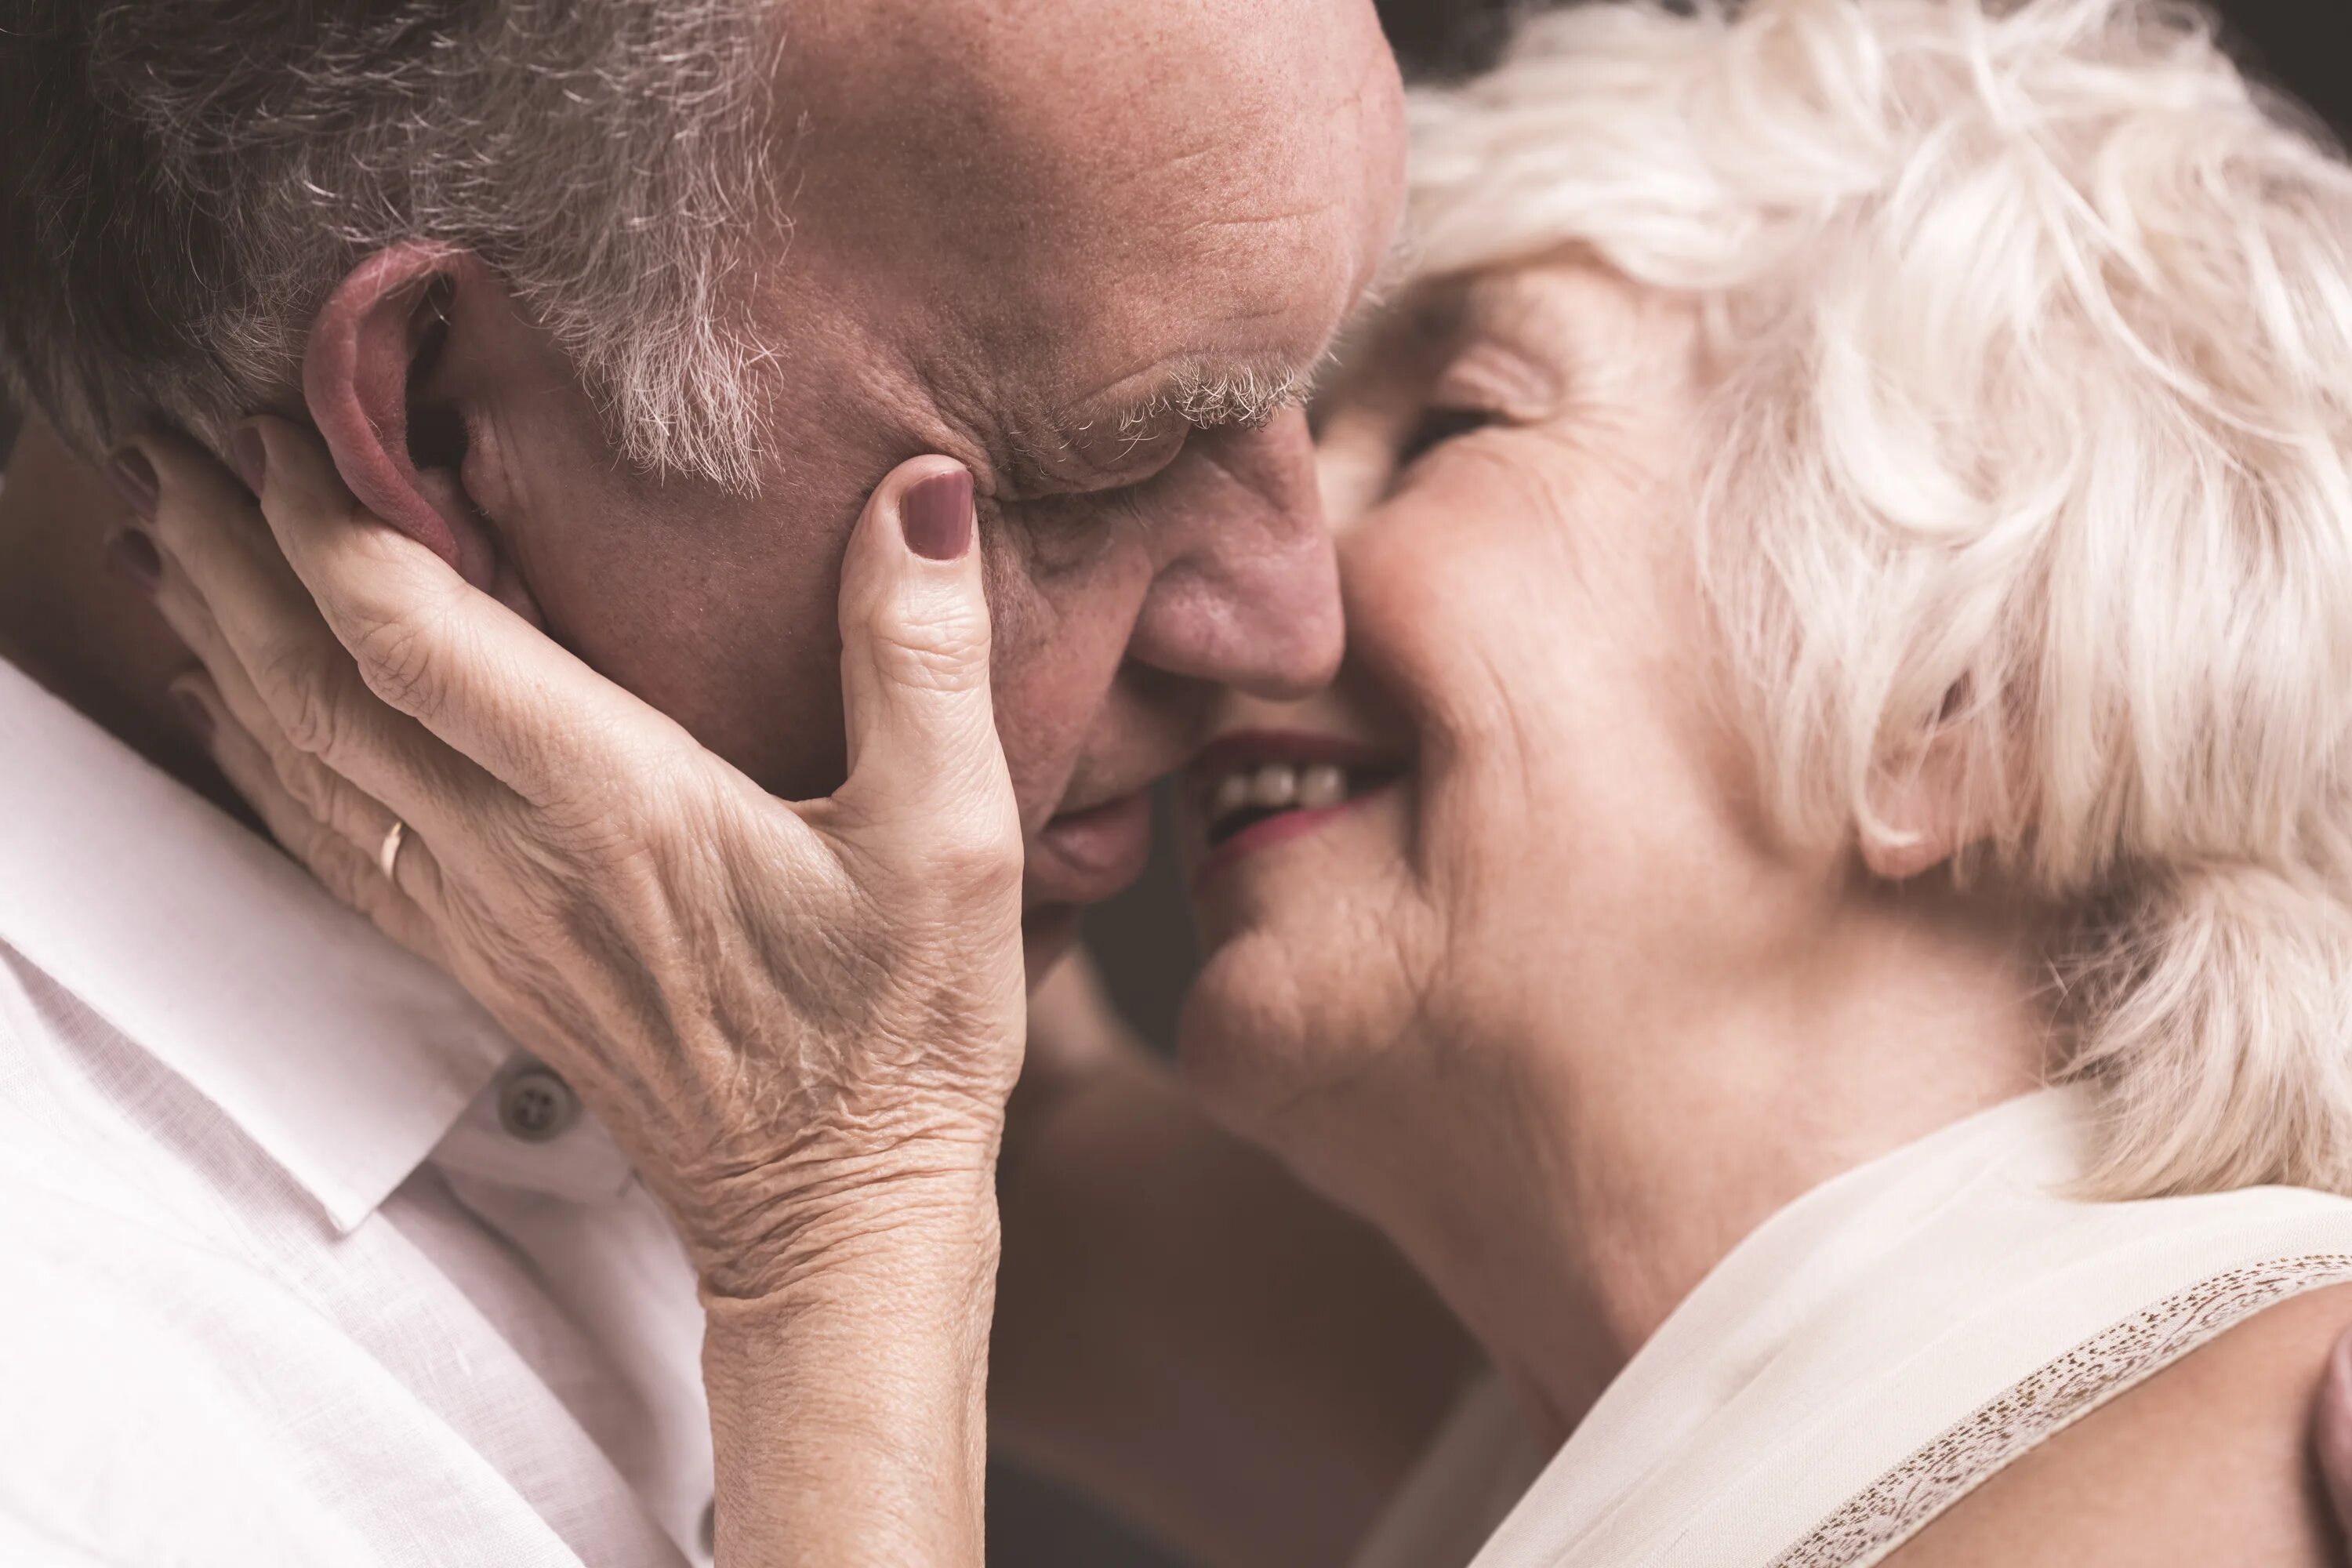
[139,437,489,846]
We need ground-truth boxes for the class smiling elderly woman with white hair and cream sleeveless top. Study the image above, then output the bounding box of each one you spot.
[111,0,2352,1568]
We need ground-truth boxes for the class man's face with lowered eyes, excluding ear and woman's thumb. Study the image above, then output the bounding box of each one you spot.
[477,0,1402,964]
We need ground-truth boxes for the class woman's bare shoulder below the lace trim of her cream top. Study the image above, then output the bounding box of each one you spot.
[1886,1283,2352,1568]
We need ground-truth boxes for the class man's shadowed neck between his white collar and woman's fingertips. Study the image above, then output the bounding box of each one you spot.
[0,421,245,815]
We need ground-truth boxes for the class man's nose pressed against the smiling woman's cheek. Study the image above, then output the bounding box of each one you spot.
[1129,409,1341,701]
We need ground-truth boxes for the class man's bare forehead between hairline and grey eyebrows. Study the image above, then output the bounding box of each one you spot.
[762,0,1395,479]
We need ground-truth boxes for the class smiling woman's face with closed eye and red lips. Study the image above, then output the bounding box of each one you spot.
[1183,261,1818,1152]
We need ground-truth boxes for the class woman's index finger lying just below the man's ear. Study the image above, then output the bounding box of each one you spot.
[245,419,691,804]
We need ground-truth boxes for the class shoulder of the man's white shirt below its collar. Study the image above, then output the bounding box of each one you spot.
[0,975,576,1568]
